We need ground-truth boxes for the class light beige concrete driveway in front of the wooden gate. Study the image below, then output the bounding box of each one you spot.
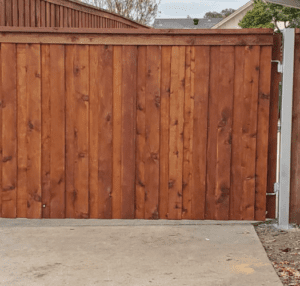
[0,219,282,286]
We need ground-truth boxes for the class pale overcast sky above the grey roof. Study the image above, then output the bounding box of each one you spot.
[156,0,249,18]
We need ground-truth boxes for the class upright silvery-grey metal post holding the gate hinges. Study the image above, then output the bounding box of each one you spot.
[277,29,295,229]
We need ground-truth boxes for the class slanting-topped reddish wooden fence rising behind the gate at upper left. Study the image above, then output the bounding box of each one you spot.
[0,0,149,28]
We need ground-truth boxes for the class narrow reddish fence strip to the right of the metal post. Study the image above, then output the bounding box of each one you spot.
[290,29,300,224]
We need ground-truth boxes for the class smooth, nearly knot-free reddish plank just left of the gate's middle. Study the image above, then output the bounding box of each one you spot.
[121,46,137,219]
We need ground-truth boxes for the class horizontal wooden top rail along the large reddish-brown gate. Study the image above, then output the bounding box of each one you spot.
[0,27,273,46]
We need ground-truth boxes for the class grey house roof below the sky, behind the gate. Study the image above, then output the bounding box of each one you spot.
[153,18,223,29]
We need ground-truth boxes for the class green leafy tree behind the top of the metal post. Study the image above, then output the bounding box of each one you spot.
[239,0,300,32]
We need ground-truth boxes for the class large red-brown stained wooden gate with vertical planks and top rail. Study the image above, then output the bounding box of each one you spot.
[0,27,277,220]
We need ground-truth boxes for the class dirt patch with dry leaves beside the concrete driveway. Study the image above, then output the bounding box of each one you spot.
[253,220,300,286]
